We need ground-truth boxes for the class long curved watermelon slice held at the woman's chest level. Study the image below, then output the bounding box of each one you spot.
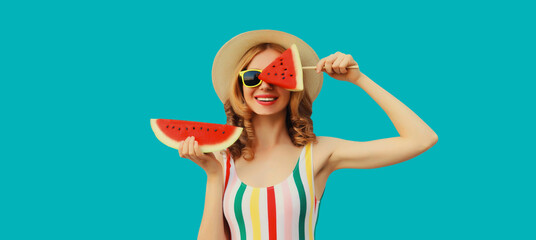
[151,119,243,153]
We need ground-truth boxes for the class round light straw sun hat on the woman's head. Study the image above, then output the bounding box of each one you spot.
[212,30,323,103]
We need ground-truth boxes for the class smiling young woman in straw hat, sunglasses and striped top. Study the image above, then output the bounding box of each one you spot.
[179,30,437,240]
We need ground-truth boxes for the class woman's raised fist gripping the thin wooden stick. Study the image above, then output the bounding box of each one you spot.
[316,52,363,83]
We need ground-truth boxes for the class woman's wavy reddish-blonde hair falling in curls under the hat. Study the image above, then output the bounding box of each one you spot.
[224,43,317,161]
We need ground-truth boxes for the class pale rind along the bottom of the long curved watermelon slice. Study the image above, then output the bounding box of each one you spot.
[151,119,244,153]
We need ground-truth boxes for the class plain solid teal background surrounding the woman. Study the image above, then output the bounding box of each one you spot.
[0,1,536,239]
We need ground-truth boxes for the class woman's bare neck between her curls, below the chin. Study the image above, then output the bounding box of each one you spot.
[251,109,292,152]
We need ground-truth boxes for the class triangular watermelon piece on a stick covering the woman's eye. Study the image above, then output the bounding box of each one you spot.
[259,44,303,91]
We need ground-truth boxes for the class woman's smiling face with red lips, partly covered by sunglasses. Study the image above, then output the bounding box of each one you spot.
[240,48,290,115]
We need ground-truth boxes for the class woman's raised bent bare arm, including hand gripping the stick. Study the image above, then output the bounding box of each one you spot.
[317,52,438,171]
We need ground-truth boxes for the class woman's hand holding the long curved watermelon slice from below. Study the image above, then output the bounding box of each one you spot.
[178,136,222,175]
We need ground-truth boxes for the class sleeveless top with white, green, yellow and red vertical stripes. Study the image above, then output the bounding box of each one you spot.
[223,143,320,240]
